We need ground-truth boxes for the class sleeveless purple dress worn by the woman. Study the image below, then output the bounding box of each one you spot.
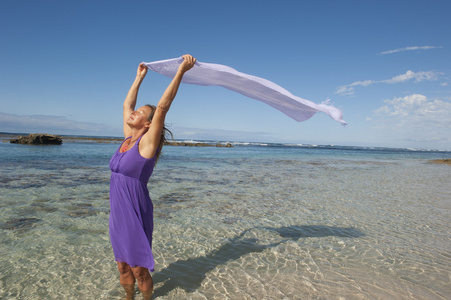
[109,137,157,272]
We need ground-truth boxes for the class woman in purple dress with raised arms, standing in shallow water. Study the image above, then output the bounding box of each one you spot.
[109,55,196,299]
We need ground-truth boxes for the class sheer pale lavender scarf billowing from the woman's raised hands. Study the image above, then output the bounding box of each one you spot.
[144,57,347,125]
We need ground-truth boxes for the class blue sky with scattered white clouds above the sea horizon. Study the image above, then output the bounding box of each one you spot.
[0,0,451,150]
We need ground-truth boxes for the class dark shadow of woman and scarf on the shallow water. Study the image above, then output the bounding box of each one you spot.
[152,225,365,298]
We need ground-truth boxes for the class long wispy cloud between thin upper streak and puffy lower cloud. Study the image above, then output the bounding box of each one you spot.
[335,70,443,96]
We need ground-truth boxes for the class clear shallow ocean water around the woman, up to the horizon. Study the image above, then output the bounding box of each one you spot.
[0,138,451,300]
